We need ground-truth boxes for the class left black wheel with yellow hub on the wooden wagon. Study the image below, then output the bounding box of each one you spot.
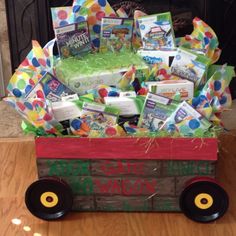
[25,178,73,220]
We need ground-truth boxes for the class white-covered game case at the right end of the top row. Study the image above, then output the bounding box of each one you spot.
[138,12,175,50]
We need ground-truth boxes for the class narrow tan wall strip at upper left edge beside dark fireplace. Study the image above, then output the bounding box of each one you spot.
[0,0,12,96]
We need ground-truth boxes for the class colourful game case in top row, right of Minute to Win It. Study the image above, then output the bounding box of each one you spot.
[100,17,134,52]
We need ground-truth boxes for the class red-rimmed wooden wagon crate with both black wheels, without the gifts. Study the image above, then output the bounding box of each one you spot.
[26,137,228,222]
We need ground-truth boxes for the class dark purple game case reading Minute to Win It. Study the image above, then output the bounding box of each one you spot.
[55,21,92,59]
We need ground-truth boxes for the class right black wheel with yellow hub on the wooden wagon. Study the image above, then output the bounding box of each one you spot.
[180,178,229,223]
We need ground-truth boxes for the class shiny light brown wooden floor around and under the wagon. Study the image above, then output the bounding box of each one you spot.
[0,139,236,236]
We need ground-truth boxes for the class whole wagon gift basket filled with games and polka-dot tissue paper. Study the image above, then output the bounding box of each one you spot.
[5,0,234,222]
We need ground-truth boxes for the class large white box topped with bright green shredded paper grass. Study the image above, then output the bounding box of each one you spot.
[56,52,149,95]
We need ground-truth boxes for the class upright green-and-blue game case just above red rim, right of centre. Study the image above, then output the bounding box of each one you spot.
[138,92,179,132]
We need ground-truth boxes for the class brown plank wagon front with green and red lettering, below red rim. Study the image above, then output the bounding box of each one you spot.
[37,159,216,212]
